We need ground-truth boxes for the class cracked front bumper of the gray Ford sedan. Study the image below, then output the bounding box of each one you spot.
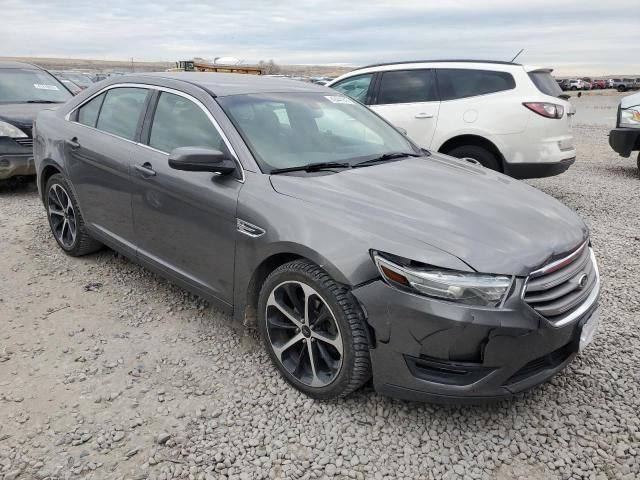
[353,279,599,403]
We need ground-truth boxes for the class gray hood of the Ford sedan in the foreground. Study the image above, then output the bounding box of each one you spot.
[271,154,588,275]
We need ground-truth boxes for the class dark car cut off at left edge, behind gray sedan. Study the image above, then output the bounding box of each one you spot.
[0,62,72,180]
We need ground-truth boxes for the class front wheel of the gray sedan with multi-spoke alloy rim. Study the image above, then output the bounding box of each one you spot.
[258,260,371,400]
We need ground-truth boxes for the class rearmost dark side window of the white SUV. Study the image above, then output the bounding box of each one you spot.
[438,68,516,100]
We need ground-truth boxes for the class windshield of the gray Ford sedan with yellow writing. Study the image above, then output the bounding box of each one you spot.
[217,93,421,172]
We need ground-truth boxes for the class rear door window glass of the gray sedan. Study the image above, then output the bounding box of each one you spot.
[96,87,147,140]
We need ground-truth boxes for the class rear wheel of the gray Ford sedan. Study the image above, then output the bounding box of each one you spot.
[45,173,102,257]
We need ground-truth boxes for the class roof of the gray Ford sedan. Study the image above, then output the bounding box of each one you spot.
[128,72,335,97]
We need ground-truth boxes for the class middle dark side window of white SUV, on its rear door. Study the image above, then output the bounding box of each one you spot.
[376,70,438,105]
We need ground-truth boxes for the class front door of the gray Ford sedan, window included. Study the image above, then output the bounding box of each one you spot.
[132,91,242,304]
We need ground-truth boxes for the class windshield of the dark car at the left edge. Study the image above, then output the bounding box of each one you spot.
[0,68,71,103]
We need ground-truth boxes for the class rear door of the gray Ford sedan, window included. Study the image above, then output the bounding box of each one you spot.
[64,87,149,254]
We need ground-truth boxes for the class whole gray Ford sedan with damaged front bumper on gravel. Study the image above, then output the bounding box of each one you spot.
[34,73,600,402]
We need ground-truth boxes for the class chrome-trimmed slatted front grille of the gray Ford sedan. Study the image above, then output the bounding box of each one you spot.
[524,243,599,322]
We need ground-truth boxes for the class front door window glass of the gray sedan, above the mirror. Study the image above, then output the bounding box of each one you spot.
[149,92,226,153]
